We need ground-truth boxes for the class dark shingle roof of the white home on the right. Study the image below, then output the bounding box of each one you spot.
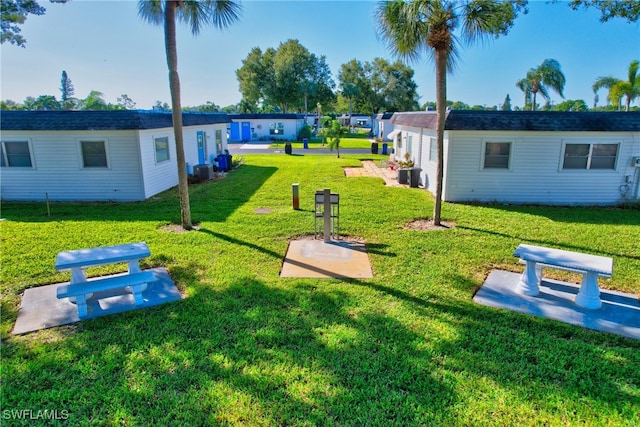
[391,110,640,132]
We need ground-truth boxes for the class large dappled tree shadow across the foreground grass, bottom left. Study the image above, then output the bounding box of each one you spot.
[3,278,456,425]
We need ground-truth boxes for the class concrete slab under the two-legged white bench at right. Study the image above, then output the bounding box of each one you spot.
[473,270,640,339]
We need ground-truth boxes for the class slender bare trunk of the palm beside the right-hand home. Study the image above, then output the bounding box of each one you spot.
[433,49,447,225]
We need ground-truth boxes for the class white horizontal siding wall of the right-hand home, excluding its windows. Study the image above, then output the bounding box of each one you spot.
[443,131,634,205]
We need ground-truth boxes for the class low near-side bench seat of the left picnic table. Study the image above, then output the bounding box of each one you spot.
[56,271,156,318]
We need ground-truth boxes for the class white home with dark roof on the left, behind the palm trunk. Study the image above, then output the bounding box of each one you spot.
[0,111,229,201]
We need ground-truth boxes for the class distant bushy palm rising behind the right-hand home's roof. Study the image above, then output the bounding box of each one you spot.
[516,59,566,111]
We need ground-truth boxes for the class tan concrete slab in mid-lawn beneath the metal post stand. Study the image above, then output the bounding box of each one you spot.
[280,239,373,279]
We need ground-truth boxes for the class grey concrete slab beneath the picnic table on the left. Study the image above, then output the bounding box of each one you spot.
[13,268,182,335]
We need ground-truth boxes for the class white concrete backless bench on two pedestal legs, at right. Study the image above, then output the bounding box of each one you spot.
[513,245,613,309]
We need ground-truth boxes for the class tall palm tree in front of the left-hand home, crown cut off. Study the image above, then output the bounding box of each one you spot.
[138,0,241,230]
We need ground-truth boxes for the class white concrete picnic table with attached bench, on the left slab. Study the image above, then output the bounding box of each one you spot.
[56,242,155,317]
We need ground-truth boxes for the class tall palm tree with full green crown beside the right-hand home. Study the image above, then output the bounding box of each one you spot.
[376,0,527,225]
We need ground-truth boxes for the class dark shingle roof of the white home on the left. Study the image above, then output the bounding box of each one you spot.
[0,110,230,130]
